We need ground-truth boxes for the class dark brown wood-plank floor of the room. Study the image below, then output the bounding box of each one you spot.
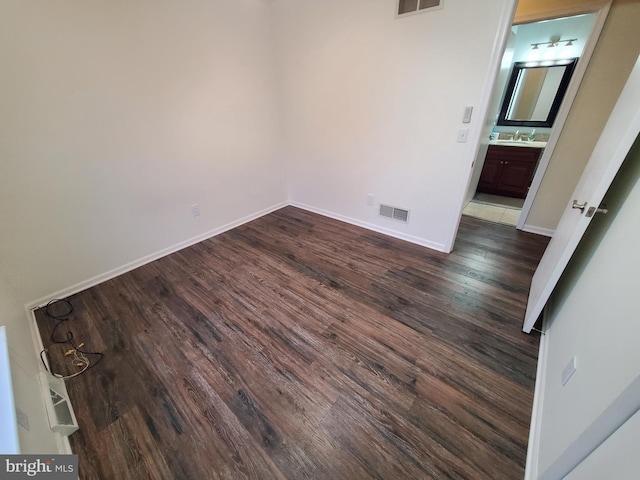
[36,207,547,480]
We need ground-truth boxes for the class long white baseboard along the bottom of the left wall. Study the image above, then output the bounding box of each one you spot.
[26,202,288,310]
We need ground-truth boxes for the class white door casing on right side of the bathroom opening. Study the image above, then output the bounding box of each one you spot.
[516,1,611,230]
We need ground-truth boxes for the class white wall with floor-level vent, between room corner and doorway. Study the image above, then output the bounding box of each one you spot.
[273,0,513,250]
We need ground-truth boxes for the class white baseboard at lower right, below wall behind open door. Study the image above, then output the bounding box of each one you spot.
[524,309,549,480]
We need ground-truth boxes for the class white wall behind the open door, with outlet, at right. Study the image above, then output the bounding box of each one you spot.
[537,134,640,474]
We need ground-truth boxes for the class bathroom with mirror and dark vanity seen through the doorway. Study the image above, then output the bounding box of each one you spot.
[463,14,595,226]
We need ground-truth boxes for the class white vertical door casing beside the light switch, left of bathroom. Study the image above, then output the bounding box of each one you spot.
[442,0,518,253]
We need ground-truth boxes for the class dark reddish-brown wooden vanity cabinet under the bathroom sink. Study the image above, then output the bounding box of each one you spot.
[477,145,542,198]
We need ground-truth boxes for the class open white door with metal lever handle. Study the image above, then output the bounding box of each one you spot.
[523,51,640,333]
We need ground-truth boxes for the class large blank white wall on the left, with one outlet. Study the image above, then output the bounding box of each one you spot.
[0,0,287,452]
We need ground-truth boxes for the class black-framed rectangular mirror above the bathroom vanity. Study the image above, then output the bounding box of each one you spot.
[497,58,578,128]
